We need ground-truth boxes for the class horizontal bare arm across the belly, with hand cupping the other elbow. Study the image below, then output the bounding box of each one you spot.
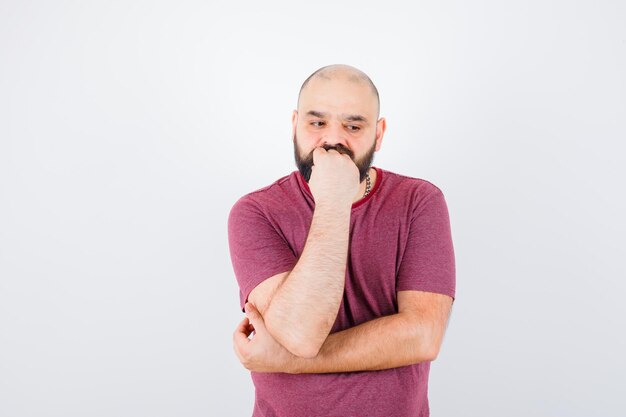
[233,291,452,373]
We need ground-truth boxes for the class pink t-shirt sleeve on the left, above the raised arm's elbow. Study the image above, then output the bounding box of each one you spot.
[228,196,297,311]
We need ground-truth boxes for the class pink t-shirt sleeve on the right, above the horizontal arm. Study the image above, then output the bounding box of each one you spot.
[396,187,456,300]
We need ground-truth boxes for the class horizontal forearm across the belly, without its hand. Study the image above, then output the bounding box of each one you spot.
[289,313,436,373]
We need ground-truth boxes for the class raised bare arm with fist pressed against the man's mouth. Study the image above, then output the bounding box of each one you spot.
[249,148,359,358]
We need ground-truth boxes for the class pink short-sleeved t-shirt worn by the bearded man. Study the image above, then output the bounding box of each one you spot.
[228,168,456,417]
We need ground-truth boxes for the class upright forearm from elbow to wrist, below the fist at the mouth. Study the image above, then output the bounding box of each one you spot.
[264,202,350,357]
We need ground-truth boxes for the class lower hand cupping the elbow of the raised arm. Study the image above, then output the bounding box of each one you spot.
[233,303,296,373]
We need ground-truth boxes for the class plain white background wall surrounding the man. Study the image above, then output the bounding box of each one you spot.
[0,0,626,417]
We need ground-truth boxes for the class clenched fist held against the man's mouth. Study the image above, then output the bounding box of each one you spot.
[309,148,360,205]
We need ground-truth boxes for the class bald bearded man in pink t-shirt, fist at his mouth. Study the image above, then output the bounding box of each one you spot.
[228,65,455,417]
